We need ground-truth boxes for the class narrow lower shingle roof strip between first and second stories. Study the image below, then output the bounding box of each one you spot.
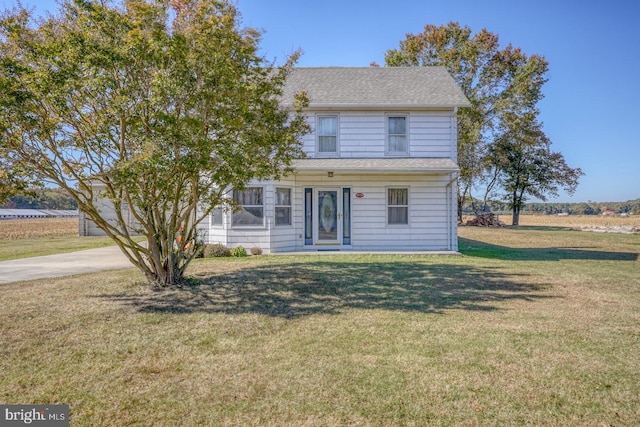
[292,157,460,174]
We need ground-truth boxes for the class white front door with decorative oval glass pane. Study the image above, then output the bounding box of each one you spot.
[315,189,342,245]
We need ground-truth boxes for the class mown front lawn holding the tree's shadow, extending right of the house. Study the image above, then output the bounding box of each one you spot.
[0,226,640,426]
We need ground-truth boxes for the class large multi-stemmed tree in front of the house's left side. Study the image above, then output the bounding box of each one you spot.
[0,0,308,285]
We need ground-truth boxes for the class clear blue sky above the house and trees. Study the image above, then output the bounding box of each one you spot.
[6,0,640,202]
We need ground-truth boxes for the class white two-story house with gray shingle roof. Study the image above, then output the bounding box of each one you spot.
[202,67,470,253]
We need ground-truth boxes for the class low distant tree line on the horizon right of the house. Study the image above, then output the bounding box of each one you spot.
[464,198,640,215]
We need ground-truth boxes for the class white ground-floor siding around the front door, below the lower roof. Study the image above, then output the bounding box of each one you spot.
[209,173,457,253]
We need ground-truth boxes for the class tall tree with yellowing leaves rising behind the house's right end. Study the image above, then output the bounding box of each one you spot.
[385,22,548,219]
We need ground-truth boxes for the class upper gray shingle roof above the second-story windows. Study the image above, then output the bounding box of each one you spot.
[283,67,470,109]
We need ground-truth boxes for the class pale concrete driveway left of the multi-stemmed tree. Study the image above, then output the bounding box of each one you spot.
[0,246,133,283]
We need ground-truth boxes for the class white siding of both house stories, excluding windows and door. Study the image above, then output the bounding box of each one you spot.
[195,109,457,253]
